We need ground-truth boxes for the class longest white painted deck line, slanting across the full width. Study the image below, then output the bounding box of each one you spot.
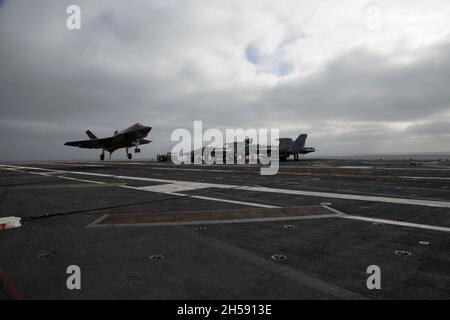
[4,165,450,208]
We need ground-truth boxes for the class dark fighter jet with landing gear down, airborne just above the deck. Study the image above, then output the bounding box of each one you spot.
[64,123,152,161]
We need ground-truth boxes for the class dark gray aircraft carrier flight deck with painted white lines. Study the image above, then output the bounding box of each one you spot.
[0,160,450,299]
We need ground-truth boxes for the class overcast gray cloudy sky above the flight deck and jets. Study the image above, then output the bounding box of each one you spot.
[0,0,450,161]
